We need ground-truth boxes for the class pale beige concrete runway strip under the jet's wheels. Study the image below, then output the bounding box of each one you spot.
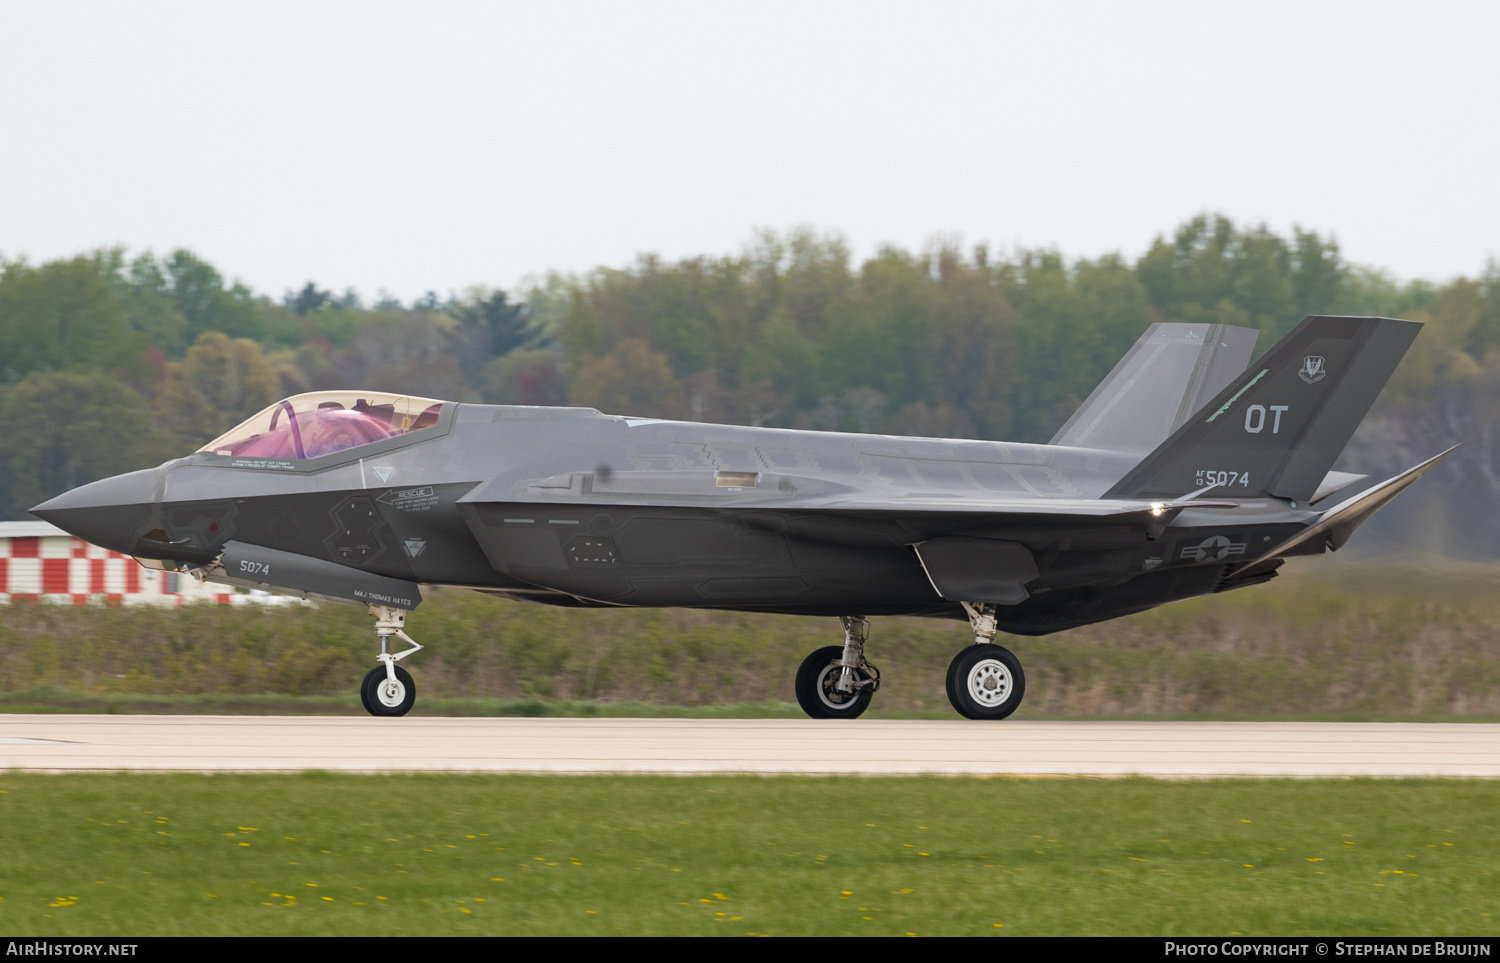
[0,716,1500,777]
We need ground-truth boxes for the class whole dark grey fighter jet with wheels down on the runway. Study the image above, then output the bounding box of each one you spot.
[32,317,1446,719]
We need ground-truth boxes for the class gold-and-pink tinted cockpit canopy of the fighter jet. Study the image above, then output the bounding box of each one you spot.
[198,392,444,461]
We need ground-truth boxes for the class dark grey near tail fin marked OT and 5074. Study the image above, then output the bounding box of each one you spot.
[1104,317,1422,504]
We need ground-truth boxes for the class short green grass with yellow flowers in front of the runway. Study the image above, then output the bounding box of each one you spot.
[0,773,1500,936]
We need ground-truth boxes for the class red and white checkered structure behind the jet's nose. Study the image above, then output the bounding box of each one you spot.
[0,522,234,606]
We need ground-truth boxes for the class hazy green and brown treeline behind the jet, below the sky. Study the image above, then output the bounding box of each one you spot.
[0,216,1500,518]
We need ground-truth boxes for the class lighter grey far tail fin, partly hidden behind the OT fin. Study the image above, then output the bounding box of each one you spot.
[1050,323,1259,455]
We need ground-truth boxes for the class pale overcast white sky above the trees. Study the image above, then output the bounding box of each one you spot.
[0,0,1500,300]
